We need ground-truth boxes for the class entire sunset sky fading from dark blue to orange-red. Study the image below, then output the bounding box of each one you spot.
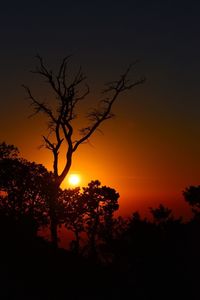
[0,0,200,216]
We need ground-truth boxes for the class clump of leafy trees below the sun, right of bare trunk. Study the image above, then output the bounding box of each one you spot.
[59,180,119,256]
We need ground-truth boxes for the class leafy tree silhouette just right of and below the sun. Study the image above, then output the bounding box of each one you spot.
[82,180,119,259]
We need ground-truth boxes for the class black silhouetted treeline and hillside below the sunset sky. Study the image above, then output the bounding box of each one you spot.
[0,143,200,299]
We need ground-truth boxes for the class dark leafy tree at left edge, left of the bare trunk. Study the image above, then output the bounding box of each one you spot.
[0,143,51,233]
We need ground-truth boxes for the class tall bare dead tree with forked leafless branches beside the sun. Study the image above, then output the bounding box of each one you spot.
[23,55,145,246]
